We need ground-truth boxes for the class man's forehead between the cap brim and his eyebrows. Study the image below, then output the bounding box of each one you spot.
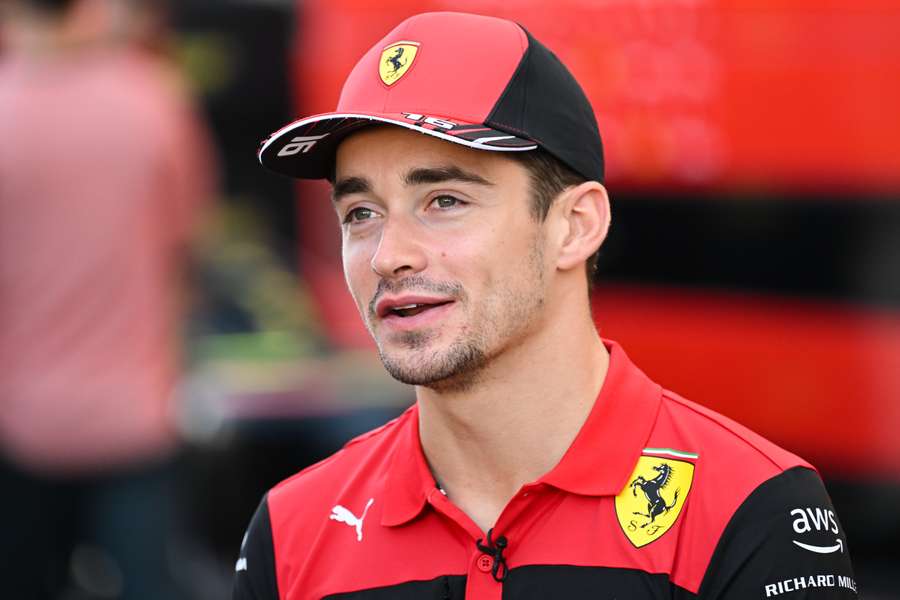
[335,125,524,181]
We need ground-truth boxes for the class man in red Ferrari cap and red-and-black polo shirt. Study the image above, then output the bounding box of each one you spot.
[234,13,856,600]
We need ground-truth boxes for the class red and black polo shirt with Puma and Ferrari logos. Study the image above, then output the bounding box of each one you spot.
[234,341,857,600]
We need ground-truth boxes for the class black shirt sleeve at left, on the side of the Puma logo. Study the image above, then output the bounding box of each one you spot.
[231,496,279,600]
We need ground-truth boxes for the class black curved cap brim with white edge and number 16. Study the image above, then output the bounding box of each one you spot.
[259,113,538,179]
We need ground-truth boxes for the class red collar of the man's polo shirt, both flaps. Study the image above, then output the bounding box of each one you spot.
[381,340,662,526]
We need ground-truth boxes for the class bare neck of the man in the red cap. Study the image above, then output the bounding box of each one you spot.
[416,290,609,531]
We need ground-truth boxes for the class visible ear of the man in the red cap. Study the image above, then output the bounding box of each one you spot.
[556,181,610,270]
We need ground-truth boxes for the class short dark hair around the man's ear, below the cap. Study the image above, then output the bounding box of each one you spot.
[506,148,600,291]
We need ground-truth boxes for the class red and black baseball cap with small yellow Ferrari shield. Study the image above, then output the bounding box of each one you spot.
[259,12,603,181]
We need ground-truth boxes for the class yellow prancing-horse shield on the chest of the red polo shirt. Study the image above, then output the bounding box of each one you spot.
[616,456,694,548]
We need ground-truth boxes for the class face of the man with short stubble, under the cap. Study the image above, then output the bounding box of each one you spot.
[334,127,551,389]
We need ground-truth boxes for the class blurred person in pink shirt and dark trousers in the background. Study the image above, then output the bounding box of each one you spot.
[0,0,214,600]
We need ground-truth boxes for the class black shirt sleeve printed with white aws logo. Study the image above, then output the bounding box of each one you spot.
[698,467,857,600]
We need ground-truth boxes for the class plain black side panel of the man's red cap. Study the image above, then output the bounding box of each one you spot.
[485,28,604,182]
